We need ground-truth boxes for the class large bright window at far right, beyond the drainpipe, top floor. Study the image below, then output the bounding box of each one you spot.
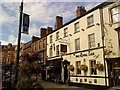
[111,6,120,23]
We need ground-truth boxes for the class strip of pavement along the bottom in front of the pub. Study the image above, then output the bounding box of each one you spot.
[41,81,93,90]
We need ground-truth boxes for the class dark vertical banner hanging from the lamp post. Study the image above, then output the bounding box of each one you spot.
[22,13,29,34]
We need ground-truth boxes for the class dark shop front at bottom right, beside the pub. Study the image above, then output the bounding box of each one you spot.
[106,57,120,87]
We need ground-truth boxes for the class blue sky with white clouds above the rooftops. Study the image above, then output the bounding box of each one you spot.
[0,0,106,45]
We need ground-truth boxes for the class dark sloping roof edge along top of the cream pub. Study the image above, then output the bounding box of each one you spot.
[47,2,114,35]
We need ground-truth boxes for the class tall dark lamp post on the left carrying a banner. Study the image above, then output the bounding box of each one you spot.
[15,0,23,84]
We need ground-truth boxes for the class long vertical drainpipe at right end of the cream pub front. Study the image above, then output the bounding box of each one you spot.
[100,7,107,86]
